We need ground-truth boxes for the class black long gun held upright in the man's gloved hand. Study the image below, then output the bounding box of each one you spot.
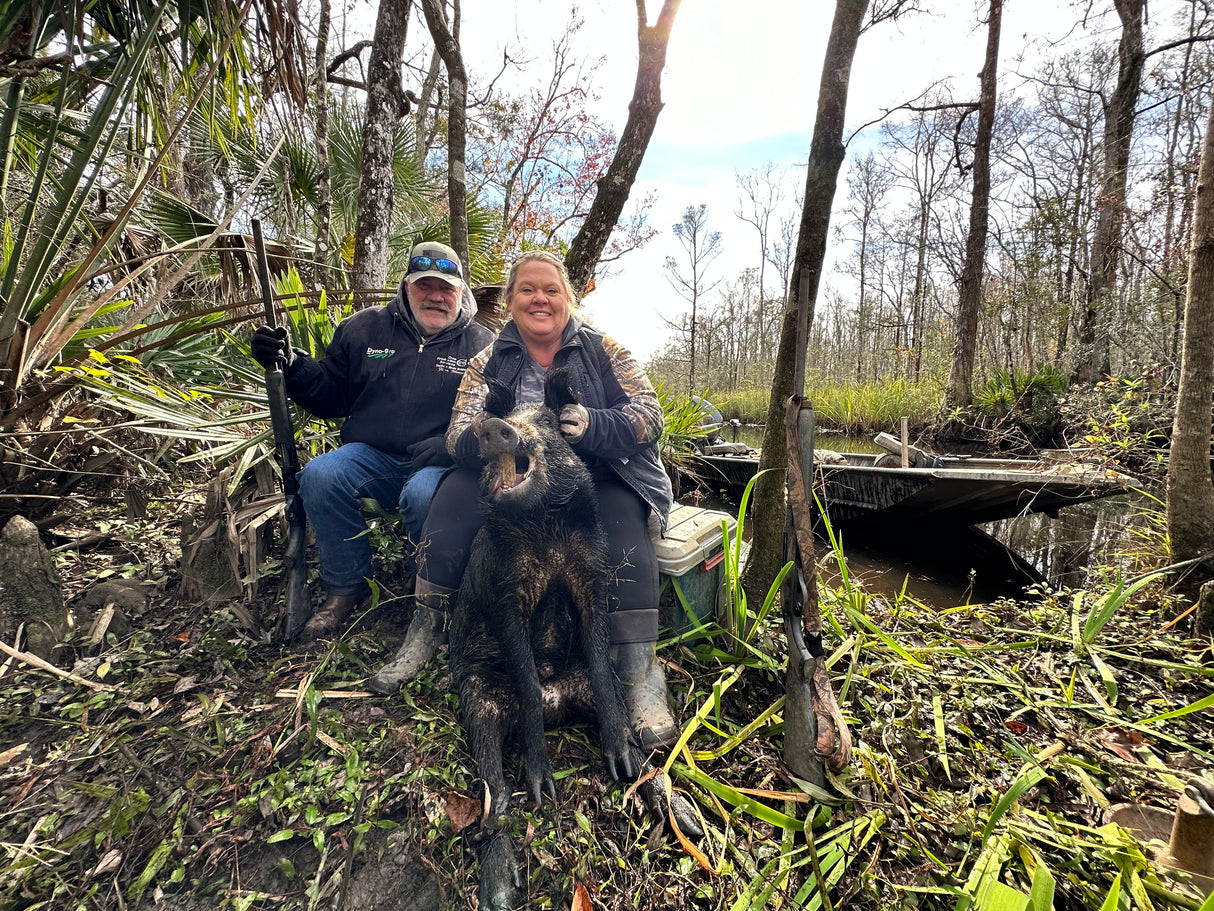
[253,219,312,641]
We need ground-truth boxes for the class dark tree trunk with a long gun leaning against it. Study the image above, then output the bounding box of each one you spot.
[742,0,868,604]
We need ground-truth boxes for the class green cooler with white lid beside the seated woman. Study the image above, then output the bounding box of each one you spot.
[654,504,738,634]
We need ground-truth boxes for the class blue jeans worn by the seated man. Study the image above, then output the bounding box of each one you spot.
[299,443,447,595]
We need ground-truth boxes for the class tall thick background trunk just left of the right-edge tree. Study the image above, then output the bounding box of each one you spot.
[1074,0,1146,385]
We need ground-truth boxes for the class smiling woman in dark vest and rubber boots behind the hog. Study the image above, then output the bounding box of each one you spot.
[371,250,679,748]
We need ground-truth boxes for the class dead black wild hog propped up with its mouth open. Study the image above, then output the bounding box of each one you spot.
[449,369,699,911]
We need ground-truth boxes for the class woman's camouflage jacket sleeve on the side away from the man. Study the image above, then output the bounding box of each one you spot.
[573,335,663,459]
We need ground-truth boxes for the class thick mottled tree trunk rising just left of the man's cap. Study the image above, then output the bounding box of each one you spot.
[350,0,413,288]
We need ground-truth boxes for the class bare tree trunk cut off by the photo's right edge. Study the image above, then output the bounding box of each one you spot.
[1168,89,1214,632]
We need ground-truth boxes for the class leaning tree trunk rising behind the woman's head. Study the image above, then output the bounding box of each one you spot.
[565,0,682,294]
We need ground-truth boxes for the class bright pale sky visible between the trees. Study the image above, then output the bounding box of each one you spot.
[463,0,1175,363]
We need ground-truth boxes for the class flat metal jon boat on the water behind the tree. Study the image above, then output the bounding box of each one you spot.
[693,434,1138,526]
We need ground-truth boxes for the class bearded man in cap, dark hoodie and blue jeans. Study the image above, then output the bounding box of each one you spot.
[251,242,493,662]
